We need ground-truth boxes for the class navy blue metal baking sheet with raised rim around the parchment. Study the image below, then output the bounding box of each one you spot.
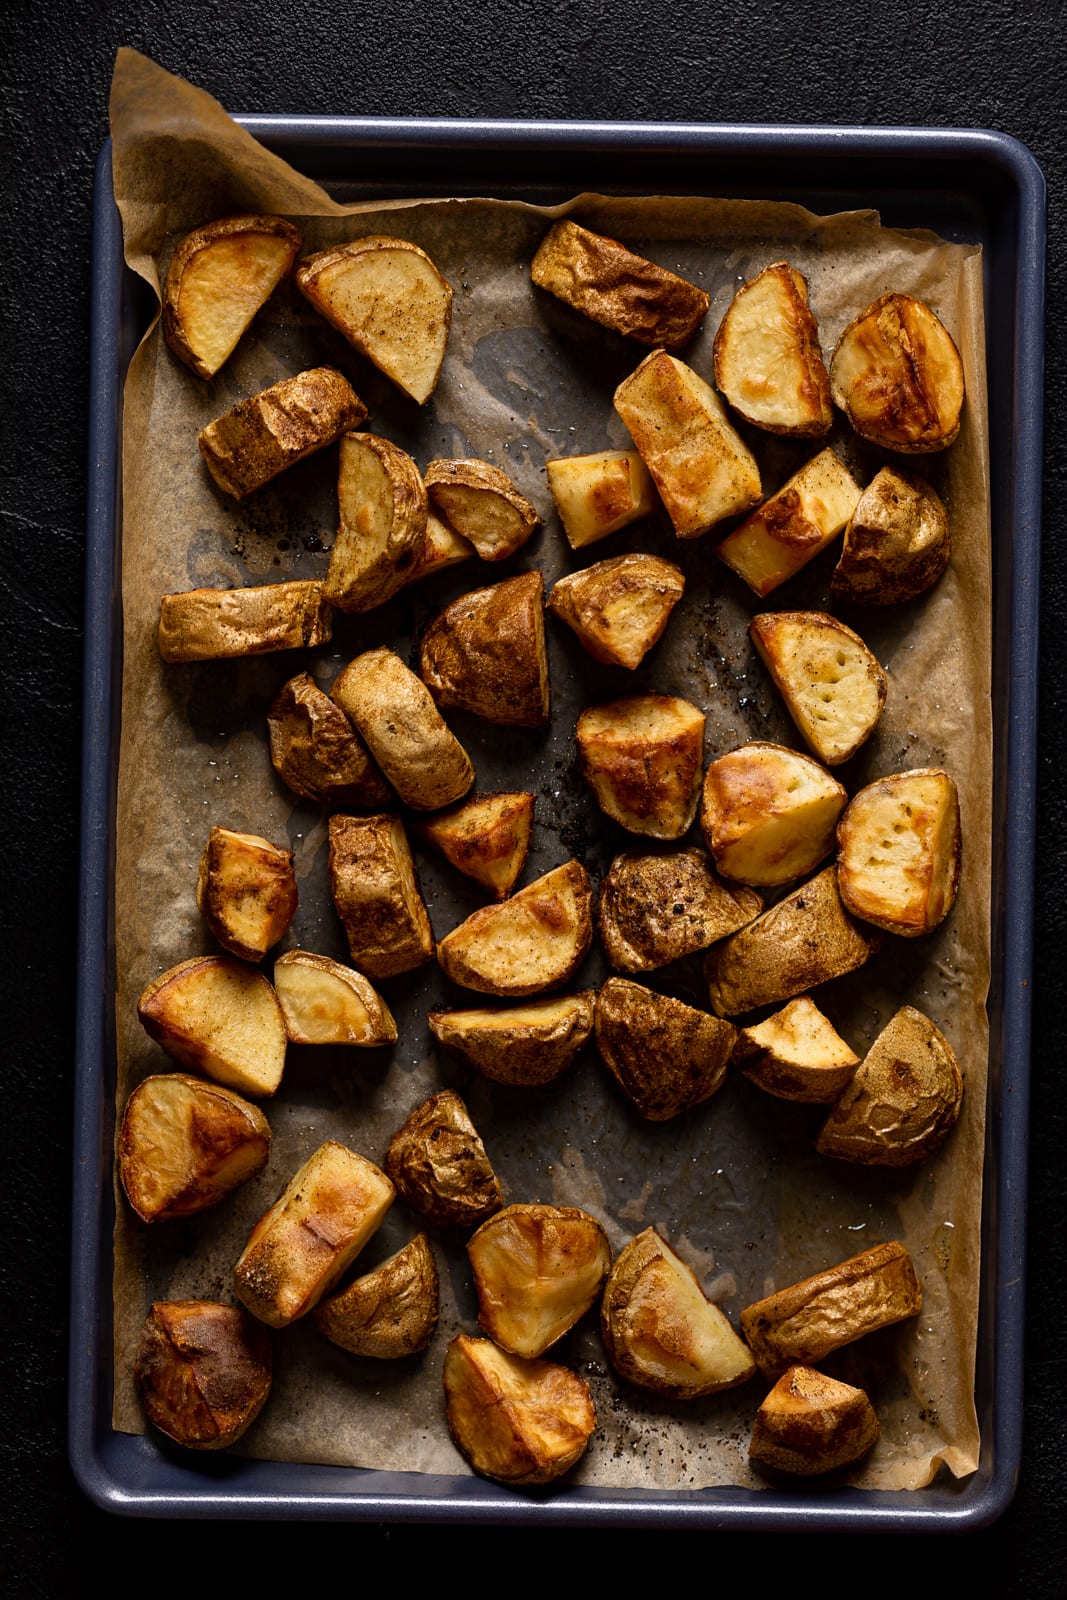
[70,115,1046,1533]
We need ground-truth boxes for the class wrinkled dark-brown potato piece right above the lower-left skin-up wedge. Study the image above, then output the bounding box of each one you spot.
[386,1090,504,1227]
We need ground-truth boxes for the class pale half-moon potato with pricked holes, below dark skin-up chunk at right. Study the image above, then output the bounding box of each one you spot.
[749,611,888,766]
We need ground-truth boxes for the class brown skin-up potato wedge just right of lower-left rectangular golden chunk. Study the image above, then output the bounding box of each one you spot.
[314,1234,440,1362]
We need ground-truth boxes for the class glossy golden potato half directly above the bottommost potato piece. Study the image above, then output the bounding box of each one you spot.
[467,1205,611,1360]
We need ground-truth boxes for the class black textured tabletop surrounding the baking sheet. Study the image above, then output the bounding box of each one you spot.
[0,0,1067,1597]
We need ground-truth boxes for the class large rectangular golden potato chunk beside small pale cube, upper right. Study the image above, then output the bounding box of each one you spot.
[614,350,763,539]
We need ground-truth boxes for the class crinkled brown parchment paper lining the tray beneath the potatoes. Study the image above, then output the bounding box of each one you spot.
[112,50,992,1490]
